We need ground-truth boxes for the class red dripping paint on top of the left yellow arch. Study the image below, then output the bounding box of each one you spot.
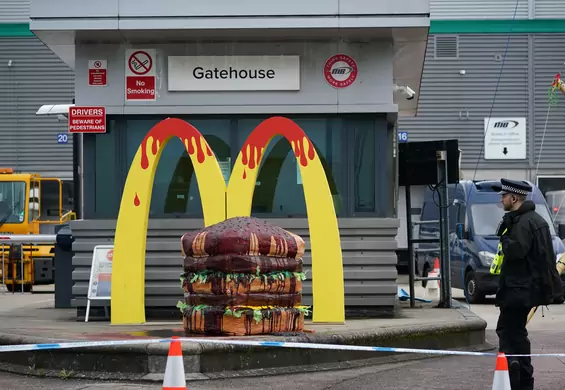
[141,118,212,169]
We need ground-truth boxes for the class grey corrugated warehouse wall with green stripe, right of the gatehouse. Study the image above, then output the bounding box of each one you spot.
[397,0,565,261]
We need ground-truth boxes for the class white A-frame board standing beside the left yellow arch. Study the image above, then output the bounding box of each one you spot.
[84,245,114,322]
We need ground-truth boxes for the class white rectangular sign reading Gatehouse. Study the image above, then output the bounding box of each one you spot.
[168,56,300,91]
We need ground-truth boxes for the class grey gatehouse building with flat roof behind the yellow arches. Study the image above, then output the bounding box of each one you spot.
[30,0,429,312]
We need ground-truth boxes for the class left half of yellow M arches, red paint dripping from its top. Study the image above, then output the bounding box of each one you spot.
[111,118,226,324]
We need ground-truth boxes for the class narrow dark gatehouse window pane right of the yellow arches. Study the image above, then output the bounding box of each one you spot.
[348,120,376,212]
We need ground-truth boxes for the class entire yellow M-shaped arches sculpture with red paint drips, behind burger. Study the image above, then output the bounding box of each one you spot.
[111,117,345,324]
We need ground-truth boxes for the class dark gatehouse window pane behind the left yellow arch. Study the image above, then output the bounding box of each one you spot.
[126,118,231,217]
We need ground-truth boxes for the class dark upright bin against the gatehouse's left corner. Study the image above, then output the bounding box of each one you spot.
[54,224,75,309]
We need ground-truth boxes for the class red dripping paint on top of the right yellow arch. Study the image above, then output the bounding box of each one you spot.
[241,117,316,179]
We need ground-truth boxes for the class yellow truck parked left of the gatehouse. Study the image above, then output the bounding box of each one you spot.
[0,168,76,292]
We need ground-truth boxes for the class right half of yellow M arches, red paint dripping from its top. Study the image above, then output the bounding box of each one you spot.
[227,117,345,323]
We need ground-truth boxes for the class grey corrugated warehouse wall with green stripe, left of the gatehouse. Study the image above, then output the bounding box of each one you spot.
[0,0,74,180]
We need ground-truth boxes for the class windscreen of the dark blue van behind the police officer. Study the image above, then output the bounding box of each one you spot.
[471,203,557,236]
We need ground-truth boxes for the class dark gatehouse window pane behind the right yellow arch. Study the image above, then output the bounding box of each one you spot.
[237,118,342,217]
